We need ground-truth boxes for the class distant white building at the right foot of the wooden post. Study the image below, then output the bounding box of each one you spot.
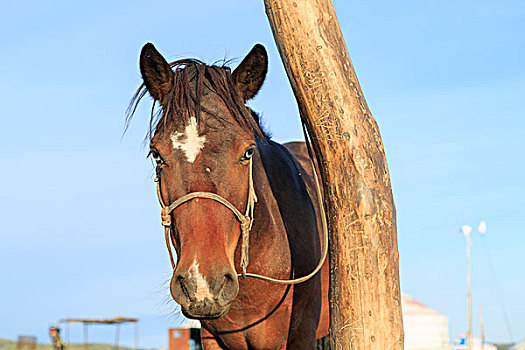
[401,294,450,350]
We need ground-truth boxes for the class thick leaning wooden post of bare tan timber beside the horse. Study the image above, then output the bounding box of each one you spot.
[264,0,403,350]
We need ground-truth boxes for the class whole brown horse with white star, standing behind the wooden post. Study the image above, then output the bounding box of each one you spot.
[132,44,328,349]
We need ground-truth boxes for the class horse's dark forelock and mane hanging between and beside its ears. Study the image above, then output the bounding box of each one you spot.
[125,58,270,139]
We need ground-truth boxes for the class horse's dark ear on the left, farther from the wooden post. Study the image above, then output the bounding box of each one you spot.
[140,43,173,101]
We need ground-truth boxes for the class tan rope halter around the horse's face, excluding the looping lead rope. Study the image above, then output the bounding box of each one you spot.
[155,158,257,278]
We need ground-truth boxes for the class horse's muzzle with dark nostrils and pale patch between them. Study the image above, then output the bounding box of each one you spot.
[170,266,239,319]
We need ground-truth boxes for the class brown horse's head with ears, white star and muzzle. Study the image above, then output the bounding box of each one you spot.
[139,44,268,319]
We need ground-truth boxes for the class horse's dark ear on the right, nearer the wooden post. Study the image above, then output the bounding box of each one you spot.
[232,44,268,101]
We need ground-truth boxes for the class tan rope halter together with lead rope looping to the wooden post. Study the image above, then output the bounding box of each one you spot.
[155,123,328,284]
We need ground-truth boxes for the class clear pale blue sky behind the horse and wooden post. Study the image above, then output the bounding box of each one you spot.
[0,0,525,346]
